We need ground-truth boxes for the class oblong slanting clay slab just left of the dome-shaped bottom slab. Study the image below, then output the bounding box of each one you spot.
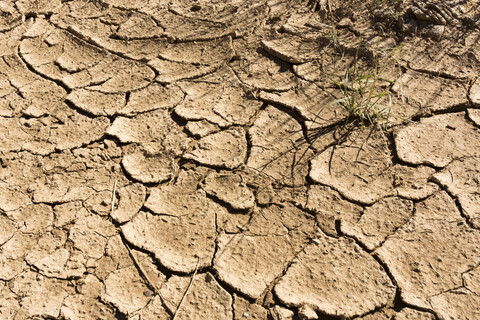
[213,205,314,299]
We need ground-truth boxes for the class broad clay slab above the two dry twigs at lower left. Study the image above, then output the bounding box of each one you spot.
[121,182,216,273]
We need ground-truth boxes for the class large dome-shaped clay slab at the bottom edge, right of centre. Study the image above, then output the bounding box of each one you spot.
[274,235,395,318]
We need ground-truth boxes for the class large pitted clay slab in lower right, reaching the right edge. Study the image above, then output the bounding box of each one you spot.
[375,191,480,312]
